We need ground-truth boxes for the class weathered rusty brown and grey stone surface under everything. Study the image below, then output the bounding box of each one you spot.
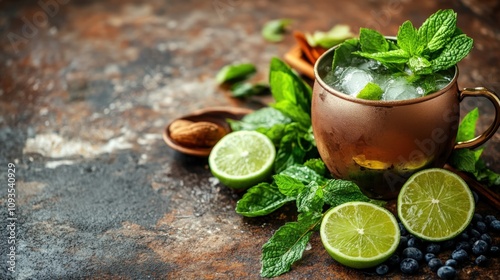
[0,0,500,279]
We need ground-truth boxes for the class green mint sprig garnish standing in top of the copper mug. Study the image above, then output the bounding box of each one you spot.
[353,9,473,75]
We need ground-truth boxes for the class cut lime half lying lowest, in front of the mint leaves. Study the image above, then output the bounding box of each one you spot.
[320,202,400,268]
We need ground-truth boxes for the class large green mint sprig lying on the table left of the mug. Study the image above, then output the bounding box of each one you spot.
[230,58,382,277]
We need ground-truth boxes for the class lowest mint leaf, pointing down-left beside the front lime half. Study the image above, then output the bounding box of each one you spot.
[260,213,322,277]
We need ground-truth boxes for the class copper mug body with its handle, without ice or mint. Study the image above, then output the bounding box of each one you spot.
[311,47,500,199]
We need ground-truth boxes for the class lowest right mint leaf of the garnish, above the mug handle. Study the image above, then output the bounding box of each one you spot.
[432,34,474,72]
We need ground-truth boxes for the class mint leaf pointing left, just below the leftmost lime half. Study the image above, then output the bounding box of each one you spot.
[236,183,295,217]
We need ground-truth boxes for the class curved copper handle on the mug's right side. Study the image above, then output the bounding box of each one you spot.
[454,87,500,149]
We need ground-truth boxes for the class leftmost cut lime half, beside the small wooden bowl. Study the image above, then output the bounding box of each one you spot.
[208,131,276,189]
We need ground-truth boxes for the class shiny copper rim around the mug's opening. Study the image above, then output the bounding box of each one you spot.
[314,36,458,107]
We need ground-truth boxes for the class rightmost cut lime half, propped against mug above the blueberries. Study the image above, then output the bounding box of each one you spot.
[398,168,474,241]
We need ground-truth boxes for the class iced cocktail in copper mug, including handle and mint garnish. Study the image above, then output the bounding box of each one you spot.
[311,10,500,199]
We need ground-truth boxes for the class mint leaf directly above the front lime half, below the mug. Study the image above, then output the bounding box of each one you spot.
[323,179,385,207]
